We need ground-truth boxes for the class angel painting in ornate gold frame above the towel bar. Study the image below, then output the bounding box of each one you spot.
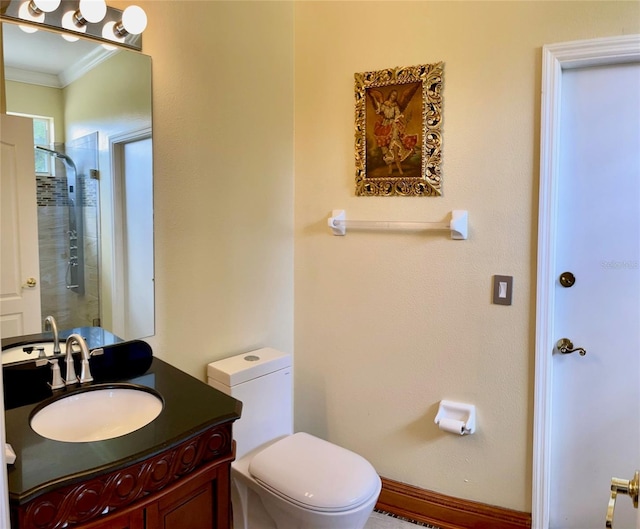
[355,62,444,196]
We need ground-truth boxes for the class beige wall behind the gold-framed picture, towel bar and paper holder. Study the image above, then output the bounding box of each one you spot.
[295,1,640,511]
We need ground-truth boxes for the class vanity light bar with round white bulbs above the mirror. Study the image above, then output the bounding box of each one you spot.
[0,0,147,51]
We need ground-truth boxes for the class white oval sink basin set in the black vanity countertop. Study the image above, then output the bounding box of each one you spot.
[31,384,163,443]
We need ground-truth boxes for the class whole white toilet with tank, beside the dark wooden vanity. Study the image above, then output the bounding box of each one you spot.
[207,348,381,529]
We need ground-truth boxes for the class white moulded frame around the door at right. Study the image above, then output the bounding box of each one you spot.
[531,35,640,529]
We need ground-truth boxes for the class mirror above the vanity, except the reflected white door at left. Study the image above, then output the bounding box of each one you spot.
[2,22,155,360]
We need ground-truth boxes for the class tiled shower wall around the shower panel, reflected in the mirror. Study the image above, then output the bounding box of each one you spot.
[36,140,100,329]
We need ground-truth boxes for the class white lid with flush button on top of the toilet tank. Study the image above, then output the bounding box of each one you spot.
[207,347,291,387]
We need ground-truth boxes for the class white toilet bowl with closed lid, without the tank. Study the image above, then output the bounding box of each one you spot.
[231,432,381,529]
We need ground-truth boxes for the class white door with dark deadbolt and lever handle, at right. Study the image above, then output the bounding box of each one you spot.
[550,59,640,529]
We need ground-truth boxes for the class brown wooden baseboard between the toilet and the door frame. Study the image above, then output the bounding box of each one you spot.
[376,478,531,529]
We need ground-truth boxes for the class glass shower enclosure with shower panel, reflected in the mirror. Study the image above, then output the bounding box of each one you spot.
[35,133,100,328]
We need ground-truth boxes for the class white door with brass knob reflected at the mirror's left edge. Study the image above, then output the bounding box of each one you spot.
[0,114,42,337]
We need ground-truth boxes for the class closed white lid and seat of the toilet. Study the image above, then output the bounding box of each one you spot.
[249,432,380,512]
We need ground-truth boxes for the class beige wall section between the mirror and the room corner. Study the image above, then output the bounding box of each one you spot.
[132,1,294,380]
